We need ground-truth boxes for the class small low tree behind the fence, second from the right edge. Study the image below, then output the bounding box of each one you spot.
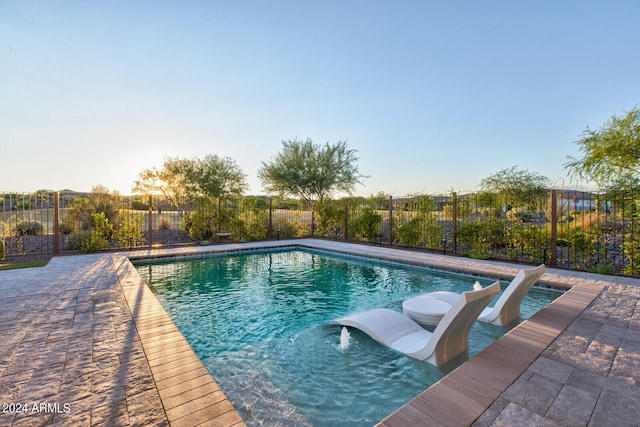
[480,166,551,204]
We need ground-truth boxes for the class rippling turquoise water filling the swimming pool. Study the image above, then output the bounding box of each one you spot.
[137,250,558,426]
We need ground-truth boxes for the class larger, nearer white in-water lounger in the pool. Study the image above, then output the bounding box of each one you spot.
[336,282,500,366]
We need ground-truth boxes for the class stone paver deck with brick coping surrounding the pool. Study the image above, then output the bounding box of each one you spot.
[0,239,640,426]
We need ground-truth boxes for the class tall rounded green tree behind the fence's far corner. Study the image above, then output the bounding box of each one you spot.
[258,139,366,202]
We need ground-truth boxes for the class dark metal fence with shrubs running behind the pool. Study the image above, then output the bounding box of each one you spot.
[0,190,640,276]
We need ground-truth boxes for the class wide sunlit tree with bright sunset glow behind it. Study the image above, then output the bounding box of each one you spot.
[133,155,247,216]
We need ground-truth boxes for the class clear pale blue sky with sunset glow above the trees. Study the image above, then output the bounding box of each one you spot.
[0,0,640,195]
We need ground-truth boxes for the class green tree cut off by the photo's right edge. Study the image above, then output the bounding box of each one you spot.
[564,107,640,187]
